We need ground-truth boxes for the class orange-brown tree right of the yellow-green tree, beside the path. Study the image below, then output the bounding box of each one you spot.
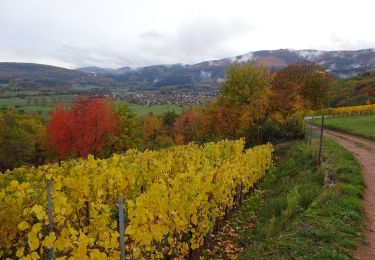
[263,62,332,140]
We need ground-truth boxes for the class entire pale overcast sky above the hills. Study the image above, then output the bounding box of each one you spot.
[0,0,375,68]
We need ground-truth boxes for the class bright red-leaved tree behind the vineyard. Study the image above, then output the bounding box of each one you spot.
[48,98,118,159]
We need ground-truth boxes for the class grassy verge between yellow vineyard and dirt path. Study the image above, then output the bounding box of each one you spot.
[222,139,364,259]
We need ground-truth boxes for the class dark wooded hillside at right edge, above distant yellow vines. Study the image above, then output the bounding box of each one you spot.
[331,71,375,107]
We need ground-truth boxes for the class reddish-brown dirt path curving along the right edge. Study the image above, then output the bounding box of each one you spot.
[324,130,375,260]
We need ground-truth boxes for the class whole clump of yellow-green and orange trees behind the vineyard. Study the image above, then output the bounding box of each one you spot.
[213,62,331,145]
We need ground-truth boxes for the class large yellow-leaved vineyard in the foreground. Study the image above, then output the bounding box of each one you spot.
[0,140,273,259]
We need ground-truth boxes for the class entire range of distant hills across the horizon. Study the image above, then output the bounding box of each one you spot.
[0,49,375,90]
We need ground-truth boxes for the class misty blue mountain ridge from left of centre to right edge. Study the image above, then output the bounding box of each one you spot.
[78,49,375,89]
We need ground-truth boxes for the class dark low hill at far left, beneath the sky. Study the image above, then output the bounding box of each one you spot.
[0,62,121,89]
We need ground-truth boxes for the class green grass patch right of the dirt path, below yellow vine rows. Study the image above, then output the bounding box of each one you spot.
[314,115,375,140]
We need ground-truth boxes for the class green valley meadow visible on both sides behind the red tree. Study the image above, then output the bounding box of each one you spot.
[0,95,189,119]
